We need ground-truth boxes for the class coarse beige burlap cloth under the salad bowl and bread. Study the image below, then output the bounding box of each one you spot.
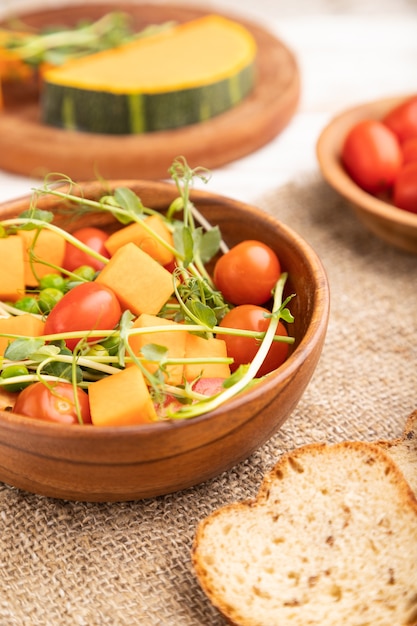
[0,173,417,626]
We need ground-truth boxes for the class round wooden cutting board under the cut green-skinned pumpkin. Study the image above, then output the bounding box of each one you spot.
[0,2,300,180]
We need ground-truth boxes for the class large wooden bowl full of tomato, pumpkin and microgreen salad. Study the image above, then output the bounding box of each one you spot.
[0,159,329,501]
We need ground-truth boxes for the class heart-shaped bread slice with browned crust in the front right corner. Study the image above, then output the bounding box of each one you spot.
[192,442,417,626]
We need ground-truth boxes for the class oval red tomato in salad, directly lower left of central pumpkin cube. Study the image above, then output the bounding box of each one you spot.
[44,282,122,350]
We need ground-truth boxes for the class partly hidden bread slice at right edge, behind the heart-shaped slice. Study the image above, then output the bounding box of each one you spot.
[378,411,417,497]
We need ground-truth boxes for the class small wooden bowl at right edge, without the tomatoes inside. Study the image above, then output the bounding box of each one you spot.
[317,97,417,254]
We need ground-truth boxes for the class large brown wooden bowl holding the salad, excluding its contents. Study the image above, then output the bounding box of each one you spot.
[0,181,329,502]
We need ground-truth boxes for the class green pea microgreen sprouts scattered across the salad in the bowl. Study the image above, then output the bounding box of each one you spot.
[0,158,294,419]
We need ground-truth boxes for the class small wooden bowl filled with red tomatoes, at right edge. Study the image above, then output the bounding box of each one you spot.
[317,95,417,254]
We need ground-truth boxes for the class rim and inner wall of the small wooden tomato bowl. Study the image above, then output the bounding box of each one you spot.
[316,94,417,229]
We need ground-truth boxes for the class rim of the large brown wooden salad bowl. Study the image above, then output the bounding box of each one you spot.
[0,179,330,440]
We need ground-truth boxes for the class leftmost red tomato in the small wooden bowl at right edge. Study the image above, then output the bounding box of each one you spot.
[342,120,402,194]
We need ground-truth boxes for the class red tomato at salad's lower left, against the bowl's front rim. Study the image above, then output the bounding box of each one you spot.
[13,382,91,424]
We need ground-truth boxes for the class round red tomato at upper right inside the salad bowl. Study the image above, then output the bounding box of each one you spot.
[213,240,281,304]
